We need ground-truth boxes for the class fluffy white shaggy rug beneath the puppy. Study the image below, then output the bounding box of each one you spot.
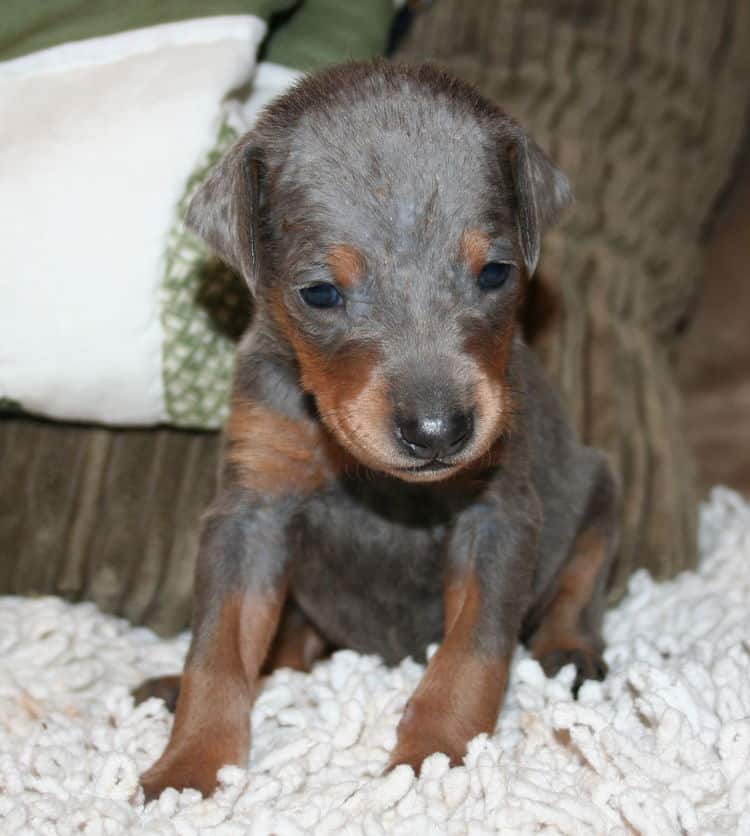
[0,489,750,836]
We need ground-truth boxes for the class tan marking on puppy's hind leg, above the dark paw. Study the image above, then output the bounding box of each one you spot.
[531,529,607,658]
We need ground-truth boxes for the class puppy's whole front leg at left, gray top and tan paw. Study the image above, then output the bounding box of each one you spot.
[141,501,286,799]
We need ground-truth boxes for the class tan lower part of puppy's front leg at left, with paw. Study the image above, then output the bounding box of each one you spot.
[141,594,283,799]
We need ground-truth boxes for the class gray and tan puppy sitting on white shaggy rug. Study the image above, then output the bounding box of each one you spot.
[138,62,615,798]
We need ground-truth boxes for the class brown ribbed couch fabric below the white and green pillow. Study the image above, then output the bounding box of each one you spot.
[0,418,219,634]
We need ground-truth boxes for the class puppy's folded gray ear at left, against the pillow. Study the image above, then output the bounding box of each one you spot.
[185,134,263,291]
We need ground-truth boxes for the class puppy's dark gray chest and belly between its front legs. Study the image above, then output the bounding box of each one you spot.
[289,489,449,661]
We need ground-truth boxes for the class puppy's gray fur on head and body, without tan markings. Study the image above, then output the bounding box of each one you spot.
[140,63,614,800]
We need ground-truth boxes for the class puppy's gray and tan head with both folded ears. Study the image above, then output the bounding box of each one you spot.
[188,62,570,481]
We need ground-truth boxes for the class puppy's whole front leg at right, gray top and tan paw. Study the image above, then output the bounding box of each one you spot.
[389,494,537,772]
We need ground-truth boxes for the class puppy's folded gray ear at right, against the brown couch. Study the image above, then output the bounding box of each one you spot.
[509,131,573,276]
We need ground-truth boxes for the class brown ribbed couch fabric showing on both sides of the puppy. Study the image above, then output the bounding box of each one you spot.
[0,0,750,632]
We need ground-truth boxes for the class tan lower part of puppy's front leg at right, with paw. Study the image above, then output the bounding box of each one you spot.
[389,574,510,772]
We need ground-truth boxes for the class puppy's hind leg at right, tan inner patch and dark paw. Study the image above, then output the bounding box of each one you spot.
[530,467,615,694]
